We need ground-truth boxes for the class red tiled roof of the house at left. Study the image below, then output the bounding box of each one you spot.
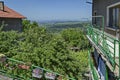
[0,6,25,18]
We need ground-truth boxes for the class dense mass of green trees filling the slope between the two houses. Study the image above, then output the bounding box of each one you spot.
[0,20,89,80]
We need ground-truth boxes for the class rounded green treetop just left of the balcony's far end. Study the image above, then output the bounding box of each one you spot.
[61,28,88,49]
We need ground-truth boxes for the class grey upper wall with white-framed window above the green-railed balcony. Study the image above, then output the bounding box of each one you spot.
[92,0,120,36]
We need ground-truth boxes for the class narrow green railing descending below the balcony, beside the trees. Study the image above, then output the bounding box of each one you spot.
[88,51,99,80]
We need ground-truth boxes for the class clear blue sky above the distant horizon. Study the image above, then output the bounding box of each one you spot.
[2,0,92,21]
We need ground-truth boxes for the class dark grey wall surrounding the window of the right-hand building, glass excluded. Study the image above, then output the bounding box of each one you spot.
[92,0,120,38]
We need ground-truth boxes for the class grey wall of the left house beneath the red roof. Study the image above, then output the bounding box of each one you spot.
[0,18,22,32]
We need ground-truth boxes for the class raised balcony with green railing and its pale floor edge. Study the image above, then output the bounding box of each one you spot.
[87,25,120,78]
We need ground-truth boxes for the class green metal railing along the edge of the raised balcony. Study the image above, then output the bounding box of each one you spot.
[87,25,120,76]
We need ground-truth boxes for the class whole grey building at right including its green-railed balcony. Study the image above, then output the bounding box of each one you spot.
[87,0,120,80]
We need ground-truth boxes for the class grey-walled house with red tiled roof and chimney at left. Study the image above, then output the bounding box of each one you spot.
[0,1,25,31]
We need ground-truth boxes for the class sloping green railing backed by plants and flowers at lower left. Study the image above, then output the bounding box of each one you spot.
[0,58,75,80]
